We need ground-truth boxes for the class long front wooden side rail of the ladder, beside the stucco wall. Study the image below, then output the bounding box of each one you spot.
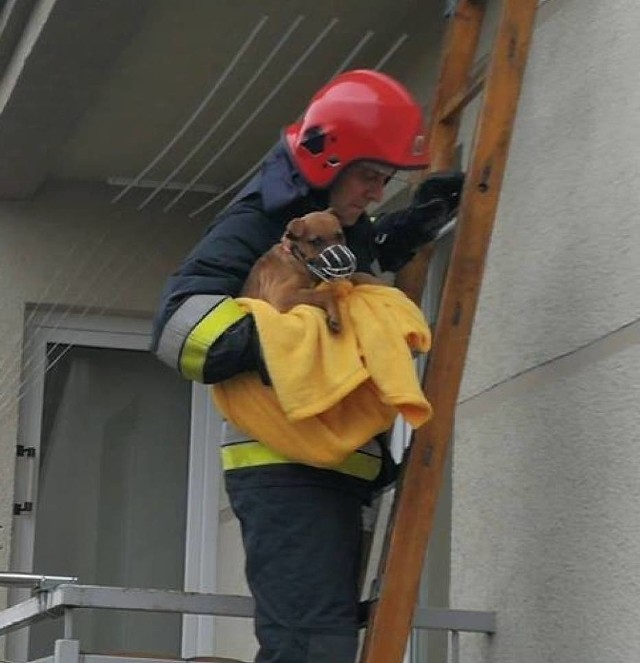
[363,0,538,663]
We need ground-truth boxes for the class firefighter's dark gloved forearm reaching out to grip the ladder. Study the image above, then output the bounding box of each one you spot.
[373,171,464,272]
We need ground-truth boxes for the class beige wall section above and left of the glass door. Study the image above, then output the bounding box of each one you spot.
[0,184,203,592]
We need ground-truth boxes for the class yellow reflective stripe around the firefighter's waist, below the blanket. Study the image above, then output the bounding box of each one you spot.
[221,441,382,481]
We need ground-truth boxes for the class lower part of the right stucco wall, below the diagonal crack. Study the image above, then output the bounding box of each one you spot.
[451,332,640,663]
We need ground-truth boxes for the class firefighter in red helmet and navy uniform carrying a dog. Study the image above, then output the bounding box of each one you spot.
[153,70,463,663]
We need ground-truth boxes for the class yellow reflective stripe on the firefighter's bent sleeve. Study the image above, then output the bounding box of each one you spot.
[180,298,246,382]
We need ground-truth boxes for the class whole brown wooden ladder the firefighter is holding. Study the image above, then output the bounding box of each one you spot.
[361,0,538,663]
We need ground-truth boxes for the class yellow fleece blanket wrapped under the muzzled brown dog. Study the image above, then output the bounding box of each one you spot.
[213,282,431,467]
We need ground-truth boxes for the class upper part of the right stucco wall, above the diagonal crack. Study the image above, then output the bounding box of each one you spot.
[463,0,640,396]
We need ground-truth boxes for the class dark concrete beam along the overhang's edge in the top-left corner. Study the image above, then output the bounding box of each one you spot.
[0,0,151,198]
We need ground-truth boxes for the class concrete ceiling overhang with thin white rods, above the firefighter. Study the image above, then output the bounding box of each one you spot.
[0,0,446,214]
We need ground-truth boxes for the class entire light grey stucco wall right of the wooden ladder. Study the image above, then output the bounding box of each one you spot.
[451,0,640,663]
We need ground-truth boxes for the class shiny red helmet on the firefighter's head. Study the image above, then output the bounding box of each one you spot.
[284,69,429,189]
